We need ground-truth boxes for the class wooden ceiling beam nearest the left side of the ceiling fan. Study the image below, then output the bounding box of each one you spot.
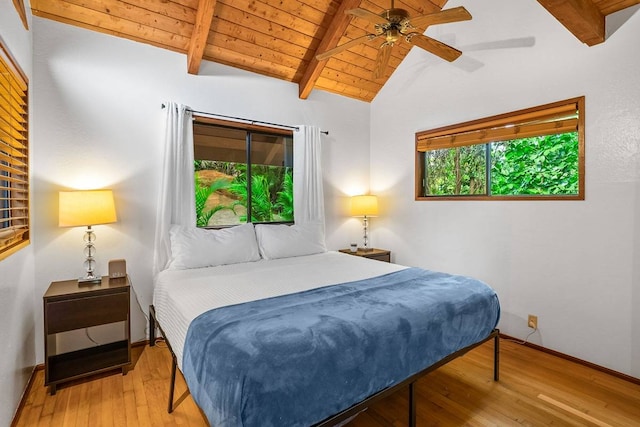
[298,0,361,99]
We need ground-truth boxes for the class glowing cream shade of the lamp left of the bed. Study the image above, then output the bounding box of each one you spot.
[58,190,118,227]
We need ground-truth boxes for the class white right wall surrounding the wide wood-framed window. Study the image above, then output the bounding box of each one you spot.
[371,0,640,377]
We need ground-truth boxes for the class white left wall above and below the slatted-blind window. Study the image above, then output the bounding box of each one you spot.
[0,1,36,426]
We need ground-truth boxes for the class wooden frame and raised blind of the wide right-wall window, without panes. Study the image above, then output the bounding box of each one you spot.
[414,96,585,201]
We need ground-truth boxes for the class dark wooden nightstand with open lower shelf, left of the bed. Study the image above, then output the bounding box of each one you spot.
[42,276,131,394]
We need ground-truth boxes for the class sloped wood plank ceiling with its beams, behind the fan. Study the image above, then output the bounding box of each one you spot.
[31,0,640,102]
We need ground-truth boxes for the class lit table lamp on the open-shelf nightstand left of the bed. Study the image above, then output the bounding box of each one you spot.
[58,190,118,284]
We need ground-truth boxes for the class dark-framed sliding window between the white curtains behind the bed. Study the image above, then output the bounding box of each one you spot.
[193,116,293,227]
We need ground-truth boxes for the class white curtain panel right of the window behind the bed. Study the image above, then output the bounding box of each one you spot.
[293,126,324,227]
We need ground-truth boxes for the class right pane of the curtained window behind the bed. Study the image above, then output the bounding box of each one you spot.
[251,133,293,222]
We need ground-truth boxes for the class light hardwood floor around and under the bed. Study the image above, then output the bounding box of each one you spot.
[16,340,640,427]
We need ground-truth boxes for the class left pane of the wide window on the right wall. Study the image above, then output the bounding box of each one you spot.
[425,145,486,196]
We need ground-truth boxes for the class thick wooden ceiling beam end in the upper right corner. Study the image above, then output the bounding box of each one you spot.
[538,0,605,46]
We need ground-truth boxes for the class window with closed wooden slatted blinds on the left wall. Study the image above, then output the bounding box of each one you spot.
[0,42,29,259]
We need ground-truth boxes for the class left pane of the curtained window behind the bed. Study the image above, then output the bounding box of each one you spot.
[193,124,247,227]
